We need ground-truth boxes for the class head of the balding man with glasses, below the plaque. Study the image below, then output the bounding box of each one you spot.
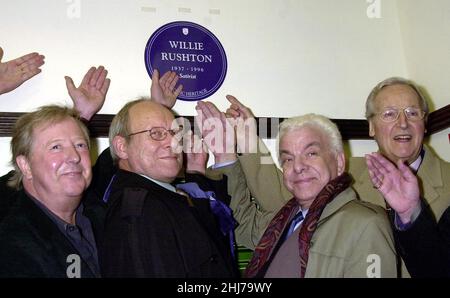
[110,99,183,182]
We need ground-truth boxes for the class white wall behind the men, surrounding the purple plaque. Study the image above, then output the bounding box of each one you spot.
[0,0,450,173]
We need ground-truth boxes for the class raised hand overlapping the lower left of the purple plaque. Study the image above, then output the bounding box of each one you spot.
[150,69,183,109]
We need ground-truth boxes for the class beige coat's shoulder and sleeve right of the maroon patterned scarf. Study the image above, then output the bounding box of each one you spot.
[305,188,397,277]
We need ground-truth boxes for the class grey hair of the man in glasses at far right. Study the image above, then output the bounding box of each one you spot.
[366,77,429,120]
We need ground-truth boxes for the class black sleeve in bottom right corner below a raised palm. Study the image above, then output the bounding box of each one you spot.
[394,205,450,277]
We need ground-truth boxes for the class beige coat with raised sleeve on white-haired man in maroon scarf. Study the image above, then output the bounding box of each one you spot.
[208,163,396,277]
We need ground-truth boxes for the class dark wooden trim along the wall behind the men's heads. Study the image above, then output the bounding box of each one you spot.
[0,105,450,140]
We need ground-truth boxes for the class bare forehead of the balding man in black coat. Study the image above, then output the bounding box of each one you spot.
[129,102,175,129]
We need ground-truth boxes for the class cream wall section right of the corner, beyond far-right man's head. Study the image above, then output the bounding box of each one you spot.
[398,0,450,161]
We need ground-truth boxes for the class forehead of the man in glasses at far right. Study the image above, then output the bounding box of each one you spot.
[375,84,420,108]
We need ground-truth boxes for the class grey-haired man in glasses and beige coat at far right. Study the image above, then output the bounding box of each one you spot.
[349,77,450,220]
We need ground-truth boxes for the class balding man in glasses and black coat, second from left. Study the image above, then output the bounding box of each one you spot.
[99,98,237,278]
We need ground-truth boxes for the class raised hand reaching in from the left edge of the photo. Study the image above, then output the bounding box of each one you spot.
[0,48,45,94]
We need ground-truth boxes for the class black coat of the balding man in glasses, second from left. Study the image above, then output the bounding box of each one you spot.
[99,170,237,278]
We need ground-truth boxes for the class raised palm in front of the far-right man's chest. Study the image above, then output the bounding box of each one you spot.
[366,153,420,223]
